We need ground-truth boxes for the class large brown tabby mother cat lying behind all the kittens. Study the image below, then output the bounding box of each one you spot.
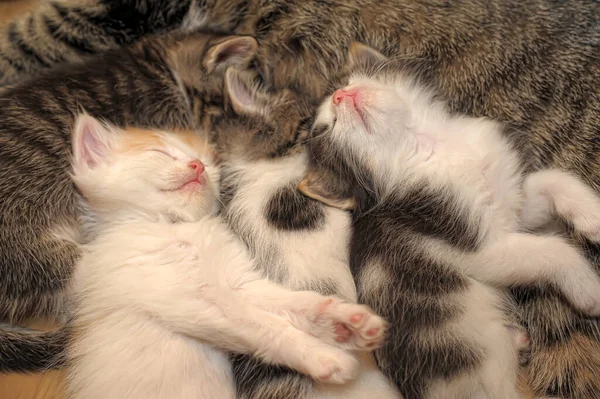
[0,0,600,398]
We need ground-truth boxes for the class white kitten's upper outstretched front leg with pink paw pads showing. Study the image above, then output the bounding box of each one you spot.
[240,279,387,351]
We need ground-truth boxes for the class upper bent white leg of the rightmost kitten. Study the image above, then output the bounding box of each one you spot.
[521,169,600,241]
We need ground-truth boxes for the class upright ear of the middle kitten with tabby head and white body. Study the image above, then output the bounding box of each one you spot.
[225,68,268,116]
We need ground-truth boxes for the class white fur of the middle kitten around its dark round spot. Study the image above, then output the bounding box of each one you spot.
[227,152,400,399]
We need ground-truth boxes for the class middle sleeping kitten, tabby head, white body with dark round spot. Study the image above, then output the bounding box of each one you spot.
[213,69,400,399]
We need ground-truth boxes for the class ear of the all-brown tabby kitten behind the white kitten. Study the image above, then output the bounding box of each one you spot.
[204,36,258,73]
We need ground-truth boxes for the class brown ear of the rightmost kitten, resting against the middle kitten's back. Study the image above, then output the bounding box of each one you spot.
[298,166,356,210]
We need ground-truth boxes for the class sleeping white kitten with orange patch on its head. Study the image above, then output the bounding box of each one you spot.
[67,115,385,399]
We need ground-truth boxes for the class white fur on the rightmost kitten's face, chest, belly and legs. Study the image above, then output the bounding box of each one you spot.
[316,73,600,399]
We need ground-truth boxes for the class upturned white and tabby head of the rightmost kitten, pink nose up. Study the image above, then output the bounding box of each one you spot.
[300,43,435,209]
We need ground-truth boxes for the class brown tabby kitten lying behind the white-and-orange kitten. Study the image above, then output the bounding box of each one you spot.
[0,33,257,328]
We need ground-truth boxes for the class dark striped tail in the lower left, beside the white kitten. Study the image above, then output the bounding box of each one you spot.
[0,324,69,373]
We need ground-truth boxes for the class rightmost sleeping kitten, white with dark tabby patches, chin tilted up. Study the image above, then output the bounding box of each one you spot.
[299,44,600,399]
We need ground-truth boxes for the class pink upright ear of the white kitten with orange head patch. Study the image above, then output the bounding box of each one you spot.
[72,114,115,169]
